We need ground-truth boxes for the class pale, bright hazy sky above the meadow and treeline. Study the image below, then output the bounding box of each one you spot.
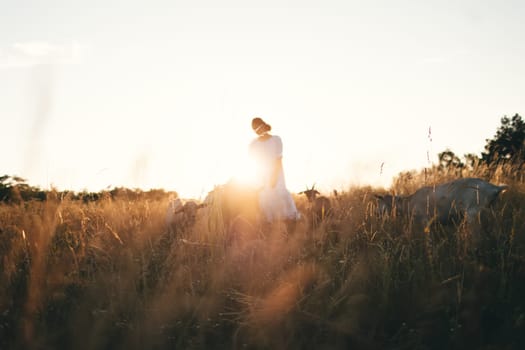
[0,0,525,198]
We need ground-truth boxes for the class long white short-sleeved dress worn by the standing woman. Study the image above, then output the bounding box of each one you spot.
[250,135,299,222]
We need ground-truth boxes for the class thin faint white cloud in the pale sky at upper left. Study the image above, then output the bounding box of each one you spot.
[0,41,88,69]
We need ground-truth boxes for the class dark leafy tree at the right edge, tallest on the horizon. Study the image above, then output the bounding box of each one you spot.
[481,114,525,166]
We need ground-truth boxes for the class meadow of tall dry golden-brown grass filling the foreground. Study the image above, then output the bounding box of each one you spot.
[0,165,525,349]
